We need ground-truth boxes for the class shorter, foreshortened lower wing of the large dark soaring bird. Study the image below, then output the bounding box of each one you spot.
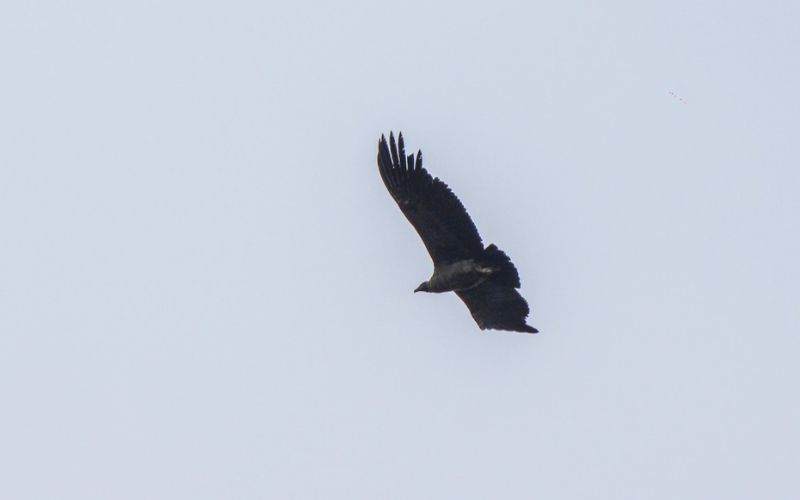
[456,284,539,333]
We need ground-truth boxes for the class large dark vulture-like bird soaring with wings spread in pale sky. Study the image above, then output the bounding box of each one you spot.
[378,133,539,333]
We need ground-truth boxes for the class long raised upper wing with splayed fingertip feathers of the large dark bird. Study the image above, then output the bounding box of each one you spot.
[378,133,483,265]
